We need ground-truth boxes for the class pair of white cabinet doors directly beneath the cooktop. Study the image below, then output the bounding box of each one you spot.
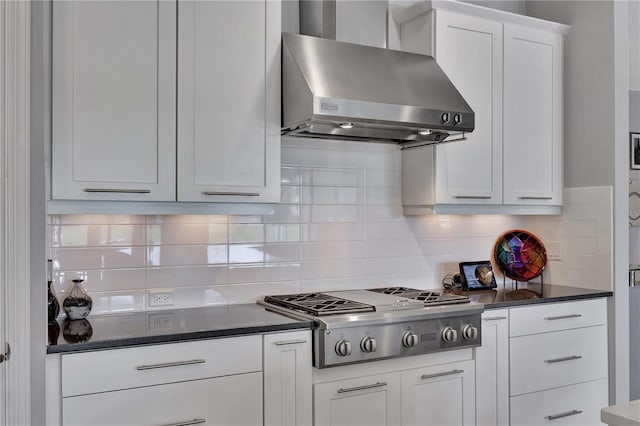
[313,349,475,426]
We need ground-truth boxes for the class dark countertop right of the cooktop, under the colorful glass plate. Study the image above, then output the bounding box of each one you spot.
[456,284,613,309]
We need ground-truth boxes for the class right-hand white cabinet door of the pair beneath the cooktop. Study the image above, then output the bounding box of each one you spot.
[402,361,476,426]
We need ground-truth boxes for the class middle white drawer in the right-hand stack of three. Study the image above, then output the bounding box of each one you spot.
[509,325,607,395]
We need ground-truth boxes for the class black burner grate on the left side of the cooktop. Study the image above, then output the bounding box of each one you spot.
[264,293,375,316]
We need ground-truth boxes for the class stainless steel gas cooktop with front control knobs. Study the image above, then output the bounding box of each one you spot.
[259,287,484,368]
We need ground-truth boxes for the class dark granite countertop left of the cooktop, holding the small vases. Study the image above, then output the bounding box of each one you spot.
[47,304,313,354]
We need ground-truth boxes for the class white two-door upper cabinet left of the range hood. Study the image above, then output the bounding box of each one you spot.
[52,0,281,203]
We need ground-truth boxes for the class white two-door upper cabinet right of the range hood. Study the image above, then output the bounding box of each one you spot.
[390,1,569,214]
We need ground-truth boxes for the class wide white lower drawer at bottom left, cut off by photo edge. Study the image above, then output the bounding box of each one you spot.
[62,373,262,426]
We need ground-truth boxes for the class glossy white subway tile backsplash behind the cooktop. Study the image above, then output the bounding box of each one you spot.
[48,137,612,315]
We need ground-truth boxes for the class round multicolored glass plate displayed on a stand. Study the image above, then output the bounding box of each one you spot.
[493,229,547,281]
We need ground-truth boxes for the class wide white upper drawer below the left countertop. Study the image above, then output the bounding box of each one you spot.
[62,336,262,397]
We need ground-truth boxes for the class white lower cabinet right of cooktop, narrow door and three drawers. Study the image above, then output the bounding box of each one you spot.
[475,298,609,426]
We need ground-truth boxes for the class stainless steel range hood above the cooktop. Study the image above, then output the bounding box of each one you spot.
[282,33,474,145]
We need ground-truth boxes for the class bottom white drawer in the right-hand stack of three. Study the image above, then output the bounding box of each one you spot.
[511,379,609,426]
